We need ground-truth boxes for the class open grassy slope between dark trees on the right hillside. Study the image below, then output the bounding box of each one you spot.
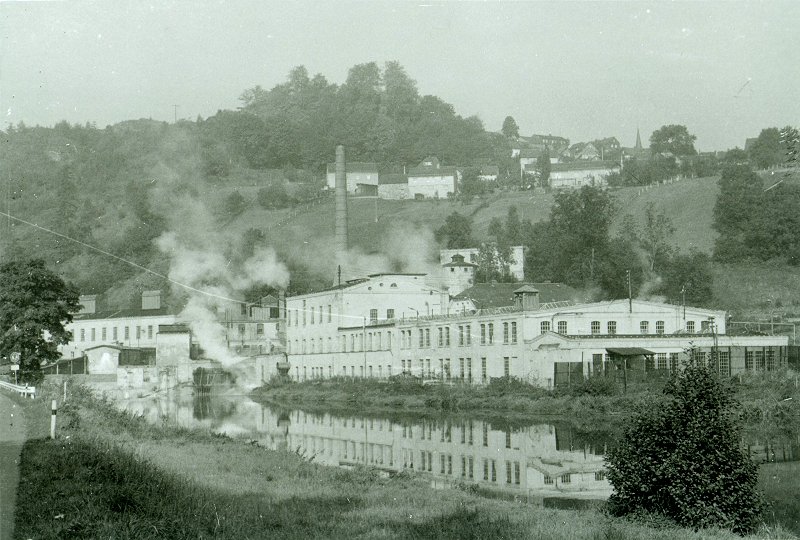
[611,176,719,255]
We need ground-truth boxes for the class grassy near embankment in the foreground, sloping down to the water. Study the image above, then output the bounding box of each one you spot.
[16,380,791,539]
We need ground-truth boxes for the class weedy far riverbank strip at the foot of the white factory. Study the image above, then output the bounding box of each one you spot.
[251,371,800,432]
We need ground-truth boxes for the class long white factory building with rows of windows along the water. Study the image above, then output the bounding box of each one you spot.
[287,274,788,386]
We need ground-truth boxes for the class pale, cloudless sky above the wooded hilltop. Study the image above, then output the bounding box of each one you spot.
[0,0,800,151]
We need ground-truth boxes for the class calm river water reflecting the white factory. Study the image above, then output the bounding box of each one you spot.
[115,386,800,532]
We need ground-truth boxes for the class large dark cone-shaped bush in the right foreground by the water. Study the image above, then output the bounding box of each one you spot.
[606,364,763,533]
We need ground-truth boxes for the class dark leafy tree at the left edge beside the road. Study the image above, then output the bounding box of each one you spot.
[0,259,80,384]
